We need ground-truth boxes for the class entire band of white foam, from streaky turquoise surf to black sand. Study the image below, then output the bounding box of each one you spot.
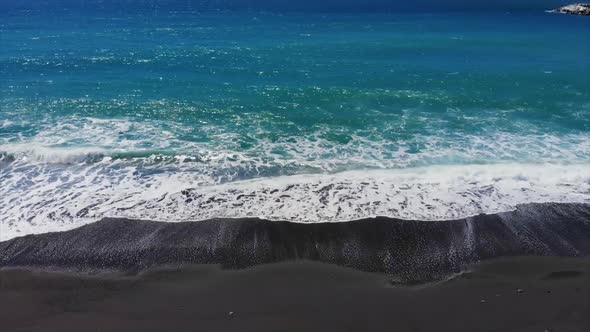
[0,115,590,240]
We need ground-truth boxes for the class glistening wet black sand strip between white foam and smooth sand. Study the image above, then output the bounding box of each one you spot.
[0,204,590,284]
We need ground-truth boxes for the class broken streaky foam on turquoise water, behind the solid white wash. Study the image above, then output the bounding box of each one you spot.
[0,113,590,172]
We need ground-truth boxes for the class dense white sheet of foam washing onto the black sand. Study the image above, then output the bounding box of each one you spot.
[0,160,590,240]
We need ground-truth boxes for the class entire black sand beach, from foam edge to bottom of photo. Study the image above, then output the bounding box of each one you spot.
[0,204,590,332]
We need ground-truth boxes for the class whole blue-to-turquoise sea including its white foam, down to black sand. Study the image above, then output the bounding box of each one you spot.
[0,11,590,239]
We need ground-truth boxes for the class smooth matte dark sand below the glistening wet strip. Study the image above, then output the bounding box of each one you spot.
[0,257,590,332]
